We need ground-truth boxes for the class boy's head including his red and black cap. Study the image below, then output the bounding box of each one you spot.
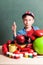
[22,11,34,27]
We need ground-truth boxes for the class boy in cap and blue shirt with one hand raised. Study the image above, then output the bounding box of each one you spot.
[12,11,39,39]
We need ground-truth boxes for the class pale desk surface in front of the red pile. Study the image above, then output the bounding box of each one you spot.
[0,46,43,65]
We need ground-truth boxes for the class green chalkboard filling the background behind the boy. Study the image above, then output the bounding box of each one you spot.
[0,0,43,45]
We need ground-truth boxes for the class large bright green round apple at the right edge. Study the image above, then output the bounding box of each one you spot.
[33,37,43,54]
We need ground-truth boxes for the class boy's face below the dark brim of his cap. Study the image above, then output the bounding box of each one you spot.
[23,15,34,28]
